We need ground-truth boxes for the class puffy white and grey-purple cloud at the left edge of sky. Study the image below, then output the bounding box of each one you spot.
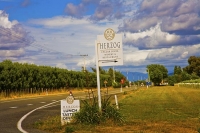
[0,10,33,58]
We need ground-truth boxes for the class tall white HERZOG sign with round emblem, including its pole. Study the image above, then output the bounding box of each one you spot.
[95,28,123,109]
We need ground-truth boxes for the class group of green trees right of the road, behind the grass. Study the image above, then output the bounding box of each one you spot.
[147,56,200,85]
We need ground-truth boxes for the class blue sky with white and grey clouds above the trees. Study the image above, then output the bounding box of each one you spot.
[0,0,200,73]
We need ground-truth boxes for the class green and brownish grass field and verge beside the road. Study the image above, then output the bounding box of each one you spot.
[36,86,200,133]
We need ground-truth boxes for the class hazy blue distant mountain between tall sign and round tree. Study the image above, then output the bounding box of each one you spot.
[121,72,148,81]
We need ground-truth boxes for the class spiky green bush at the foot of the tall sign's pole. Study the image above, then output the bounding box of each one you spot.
[74,97,123,124]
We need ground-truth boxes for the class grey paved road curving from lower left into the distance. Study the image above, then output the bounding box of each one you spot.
[0,88,135,133]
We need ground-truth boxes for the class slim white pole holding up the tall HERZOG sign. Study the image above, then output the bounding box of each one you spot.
[95,41,101,111]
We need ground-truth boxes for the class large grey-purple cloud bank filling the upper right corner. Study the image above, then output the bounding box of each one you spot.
[120,0,200,35]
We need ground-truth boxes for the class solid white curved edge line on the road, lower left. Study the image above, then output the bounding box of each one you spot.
[17,101,60,133]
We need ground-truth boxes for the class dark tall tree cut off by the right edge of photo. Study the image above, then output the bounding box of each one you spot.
[184,56,200,77]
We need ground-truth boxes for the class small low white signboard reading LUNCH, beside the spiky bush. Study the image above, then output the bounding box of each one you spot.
[61,96,80,125]
